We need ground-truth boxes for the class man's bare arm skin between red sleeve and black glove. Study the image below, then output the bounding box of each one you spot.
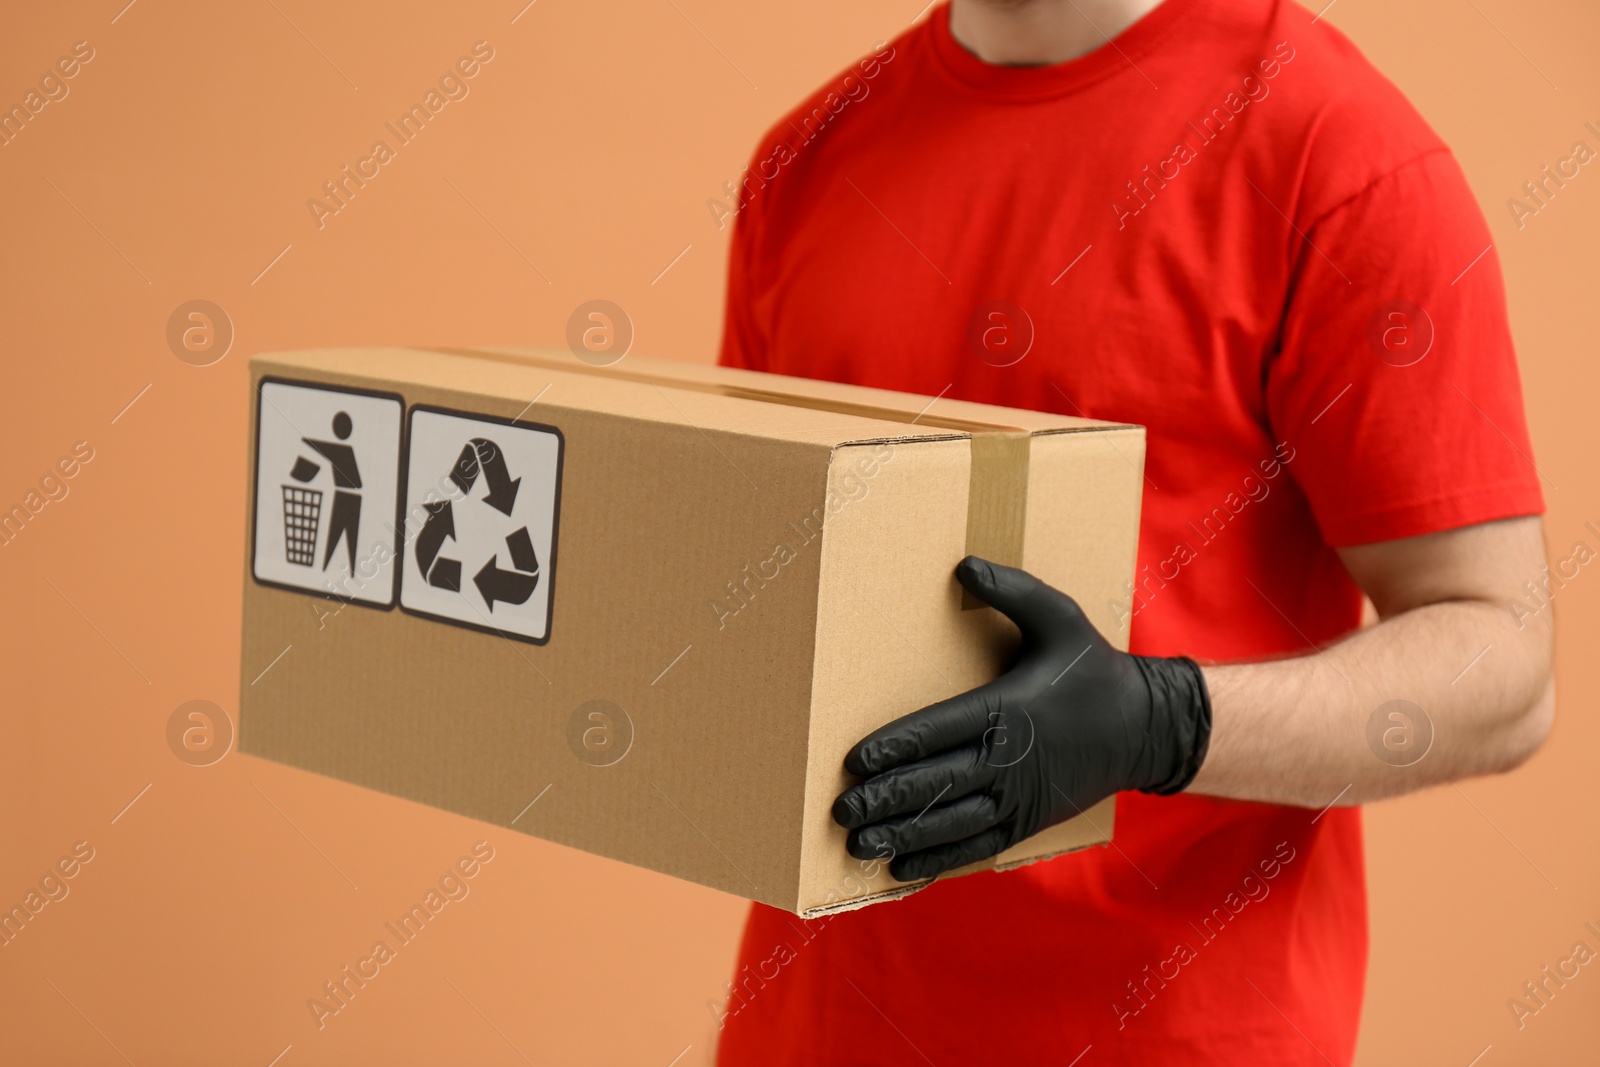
[1189,518,1555,808]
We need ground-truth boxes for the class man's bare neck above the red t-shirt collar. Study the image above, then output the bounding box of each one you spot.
[950,0,1162,67]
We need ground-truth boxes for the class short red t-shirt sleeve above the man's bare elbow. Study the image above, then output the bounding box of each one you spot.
[1266,149,1544,545]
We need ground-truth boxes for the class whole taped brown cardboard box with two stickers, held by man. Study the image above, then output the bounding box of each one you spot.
[240,349,1144,917]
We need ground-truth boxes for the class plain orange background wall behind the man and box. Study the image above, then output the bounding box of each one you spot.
[0,0,1600,1067]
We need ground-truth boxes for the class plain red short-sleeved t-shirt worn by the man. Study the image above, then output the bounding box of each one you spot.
[722,0,1542,1067]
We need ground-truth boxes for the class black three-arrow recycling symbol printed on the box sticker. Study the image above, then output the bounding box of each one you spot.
[416,437,539,611]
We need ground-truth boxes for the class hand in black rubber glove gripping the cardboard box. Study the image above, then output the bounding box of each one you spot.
[834,555,1211,881]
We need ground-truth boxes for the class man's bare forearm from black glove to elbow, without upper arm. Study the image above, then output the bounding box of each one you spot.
[1189,600,1555,808]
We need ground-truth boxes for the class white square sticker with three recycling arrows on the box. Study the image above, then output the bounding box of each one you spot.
[400,408,562,645]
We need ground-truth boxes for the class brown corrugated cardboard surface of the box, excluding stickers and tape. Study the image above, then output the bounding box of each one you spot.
[240,349,1142,912]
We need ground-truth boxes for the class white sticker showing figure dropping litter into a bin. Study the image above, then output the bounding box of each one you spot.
[253,379,405,608]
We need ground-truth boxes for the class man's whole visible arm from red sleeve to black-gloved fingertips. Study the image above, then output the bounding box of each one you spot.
[834,518,1554,881]
